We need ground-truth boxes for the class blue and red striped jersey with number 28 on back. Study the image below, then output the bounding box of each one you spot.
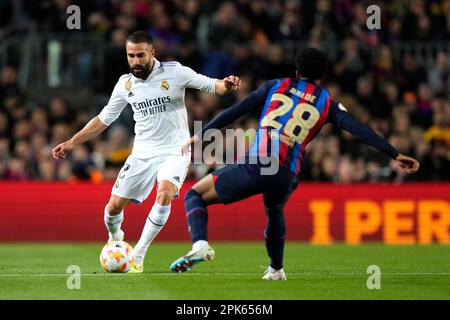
[249,78,330,174]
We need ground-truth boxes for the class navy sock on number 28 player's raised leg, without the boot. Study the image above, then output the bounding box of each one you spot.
[184,189,208,243]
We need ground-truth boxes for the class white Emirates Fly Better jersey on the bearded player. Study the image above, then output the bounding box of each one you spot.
[98,59,217,159]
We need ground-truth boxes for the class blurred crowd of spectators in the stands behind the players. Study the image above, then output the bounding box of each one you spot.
[0,0,450,183]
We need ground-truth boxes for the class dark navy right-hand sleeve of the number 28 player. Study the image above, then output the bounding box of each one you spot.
[327,101,399,159]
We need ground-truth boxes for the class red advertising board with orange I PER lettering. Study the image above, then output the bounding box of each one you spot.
[0,182,450,244]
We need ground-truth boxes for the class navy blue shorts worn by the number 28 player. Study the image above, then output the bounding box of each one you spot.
[212,164,298,204]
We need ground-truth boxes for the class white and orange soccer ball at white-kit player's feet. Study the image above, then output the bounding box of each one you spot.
[100,240,134,273]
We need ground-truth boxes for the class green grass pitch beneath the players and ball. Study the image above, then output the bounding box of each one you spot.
[0,242,450,300]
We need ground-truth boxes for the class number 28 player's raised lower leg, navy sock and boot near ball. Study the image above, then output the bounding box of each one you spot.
[170,186,215,273]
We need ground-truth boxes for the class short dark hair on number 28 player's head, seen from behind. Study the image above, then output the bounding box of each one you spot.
[295,48,328,80]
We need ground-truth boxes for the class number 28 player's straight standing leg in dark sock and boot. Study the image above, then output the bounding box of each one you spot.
[263,194,287,280]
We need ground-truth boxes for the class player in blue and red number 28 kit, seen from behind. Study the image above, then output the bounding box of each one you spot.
[170,48,419,280]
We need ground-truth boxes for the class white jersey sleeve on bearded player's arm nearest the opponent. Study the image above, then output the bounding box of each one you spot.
[175,62,217,93]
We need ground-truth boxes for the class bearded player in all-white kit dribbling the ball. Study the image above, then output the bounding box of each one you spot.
[52,31,240,273]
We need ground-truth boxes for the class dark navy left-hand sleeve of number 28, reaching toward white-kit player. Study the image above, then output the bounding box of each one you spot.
[197,80,276,135]
